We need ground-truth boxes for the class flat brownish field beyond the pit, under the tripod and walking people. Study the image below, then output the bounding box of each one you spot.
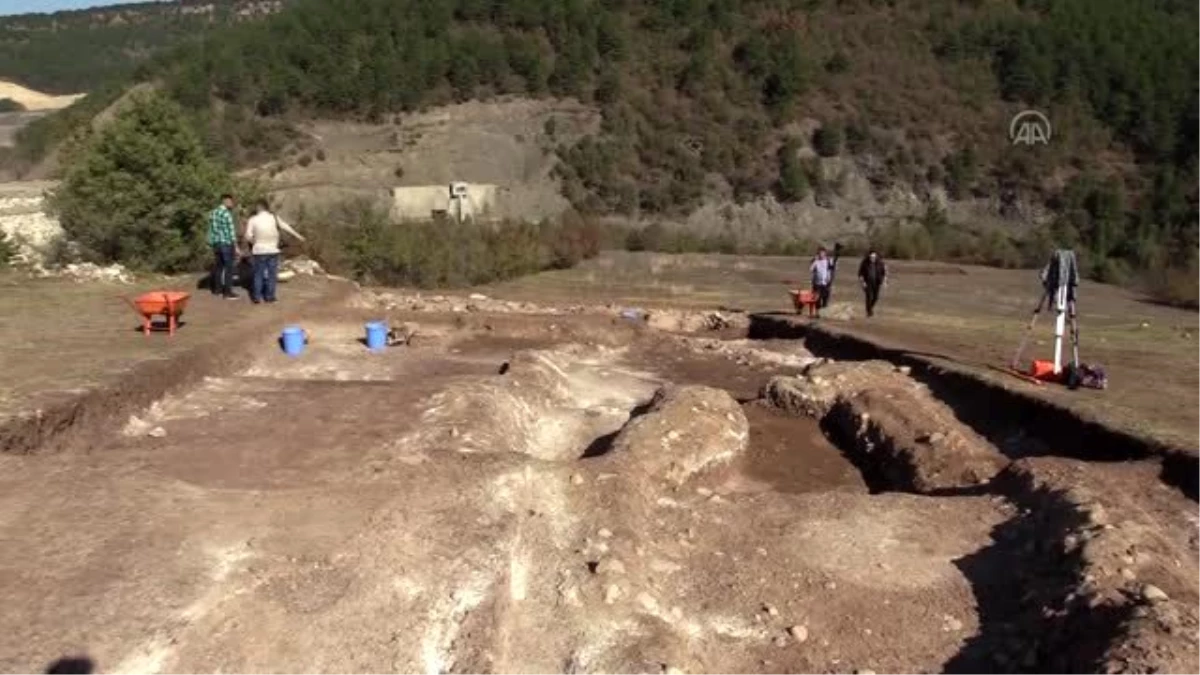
[488,253,1200,449]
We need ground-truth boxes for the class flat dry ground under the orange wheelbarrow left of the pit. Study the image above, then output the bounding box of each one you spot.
[0,273,345,452]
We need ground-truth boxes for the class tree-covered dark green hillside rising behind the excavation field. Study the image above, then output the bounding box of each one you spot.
[9,0,1200,285]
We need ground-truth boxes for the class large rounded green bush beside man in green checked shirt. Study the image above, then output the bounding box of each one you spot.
[49,94,234,273]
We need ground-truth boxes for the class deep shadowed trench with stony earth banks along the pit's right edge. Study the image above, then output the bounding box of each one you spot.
[751,317,1198,674]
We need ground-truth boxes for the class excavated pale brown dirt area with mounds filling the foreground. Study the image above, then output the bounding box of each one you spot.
[0,293,1200,675]
